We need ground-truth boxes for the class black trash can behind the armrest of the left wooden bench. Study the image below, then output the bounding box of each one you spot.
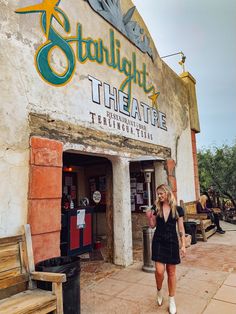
[35,256,80,314]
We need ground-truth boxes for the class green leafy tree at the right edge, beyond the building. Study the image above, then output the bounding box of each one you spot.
[198,142,236,208]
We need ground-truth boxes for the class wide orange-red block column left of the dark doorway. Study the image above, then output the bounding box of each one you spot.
[28,137,63,263]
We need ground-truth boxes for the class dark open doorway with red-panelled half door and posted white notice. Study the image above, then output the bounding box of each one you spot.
[61,152,113,261]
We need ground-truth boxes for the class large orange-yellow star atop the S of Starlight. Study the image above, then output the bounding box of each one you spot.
[15,0,63,39]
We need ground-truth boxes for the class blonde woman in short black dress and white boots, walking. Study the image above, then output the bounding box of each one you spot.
[146,184,186,314]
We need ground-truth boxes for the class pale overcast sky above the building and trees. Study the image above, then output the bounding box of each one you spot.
[133,0,236,148]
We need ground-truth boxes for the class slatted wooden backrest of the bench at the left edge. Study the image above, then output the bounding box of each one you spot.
[0,235,29,300]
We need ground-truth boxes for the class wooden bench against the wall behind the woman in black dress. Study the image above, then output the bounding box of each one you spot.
[180,200,216,242]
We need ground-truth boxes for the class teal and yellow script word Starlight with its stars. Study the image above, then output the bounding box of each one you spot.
[16,0,159,100]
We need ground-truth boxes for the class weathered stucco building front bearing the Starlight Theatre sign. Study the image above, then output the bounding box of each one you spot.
[0,0,200,266]
